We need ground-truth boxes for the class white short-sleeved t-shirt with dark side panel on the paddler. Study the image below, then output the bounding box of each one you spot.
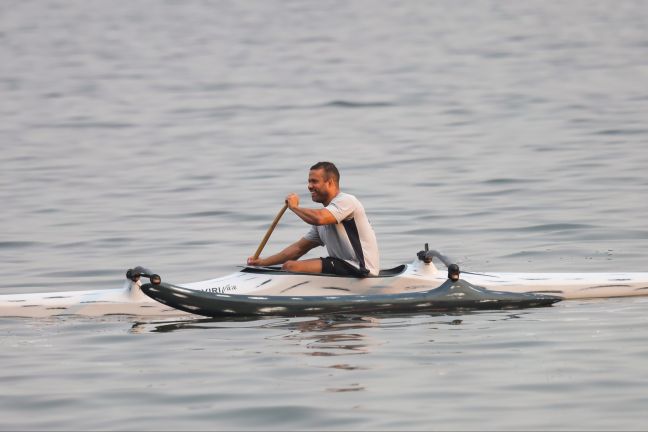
[304,192,380,275]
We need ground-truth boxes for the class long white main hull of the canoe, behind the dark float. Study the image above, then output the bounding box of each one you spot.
[0,261,648,317]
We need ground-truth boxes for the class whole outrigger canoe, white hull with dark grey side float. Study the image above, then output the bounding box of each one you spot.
[0,245,648,317]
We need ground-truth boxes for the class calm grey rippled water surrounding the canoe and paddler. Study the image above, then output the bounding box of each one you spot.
[0,0,648,430]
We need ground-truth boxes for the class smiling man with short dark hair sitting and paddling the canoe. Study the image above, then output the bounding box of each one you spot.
[247,162,380,277]
